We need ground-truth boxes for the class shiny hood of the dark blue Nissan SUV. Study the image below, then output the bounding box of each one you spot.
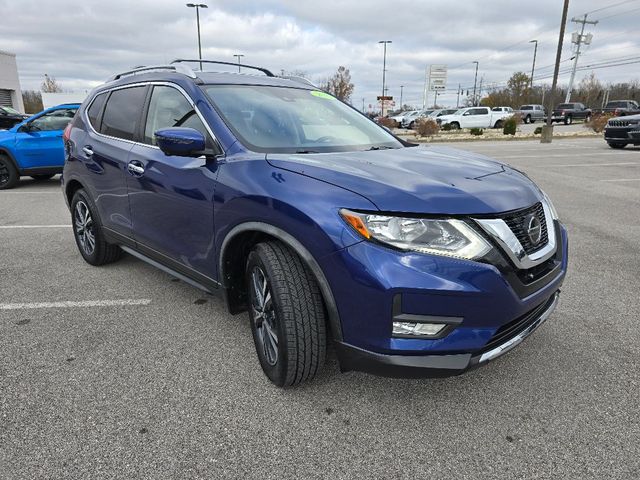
[267,146,542,215]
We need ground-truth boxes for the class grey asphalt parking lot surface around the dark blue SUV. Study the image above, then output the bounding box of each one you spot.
[0,139,640,479]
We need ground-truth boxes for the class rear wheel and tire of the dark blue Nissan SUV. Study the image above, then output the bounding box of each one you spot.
[71,189,122,266]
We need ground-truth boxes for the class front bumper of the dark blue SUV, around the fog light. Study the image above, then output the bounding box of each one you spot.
[321,218,568,377]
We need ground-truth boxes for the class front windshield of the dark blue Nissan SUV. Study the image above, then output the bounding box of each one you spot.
[203,85,402,153]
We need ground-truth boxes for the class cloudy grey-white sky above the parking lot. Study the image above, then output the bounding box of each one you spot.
[0,0,640,107]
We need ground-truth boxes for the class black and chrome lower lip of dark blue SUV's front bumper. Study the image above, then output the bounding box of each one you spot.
[336,290,560,378]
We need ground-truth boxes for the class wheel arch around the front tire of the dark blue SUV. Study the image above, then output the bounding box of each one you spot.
[218,222,342,341]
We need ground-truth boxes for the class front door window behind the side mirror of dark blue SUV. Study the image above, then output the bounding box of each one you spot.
[144,86,212,147]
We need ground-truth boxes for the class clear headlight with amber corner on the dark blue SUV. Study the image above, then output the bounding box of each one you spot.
[340,209,491,260]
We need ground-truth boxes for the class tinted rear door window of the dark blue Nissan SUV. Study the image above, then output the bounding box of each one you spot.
[100,86,146,140]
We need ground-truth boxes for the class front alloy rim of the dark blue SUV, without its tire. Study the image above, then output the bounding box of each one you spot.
[251,266,278,366]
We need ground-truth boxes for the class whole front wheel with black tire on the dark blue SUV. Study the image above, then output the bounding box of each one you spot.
[246,241,327,387]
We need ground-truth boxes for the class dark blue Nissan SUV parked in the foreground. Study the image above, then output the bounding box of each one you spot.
[63,61,567,386]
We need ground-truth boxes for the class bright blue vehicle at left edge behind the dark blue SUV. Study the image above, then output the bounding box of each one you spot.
[0,104,80,190]
